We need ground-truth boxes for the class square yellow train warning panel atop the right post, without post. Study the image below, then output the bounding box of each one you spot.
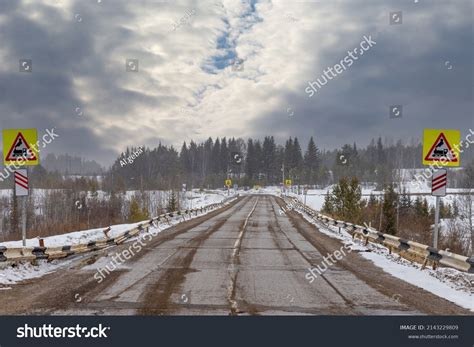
[423,129,461,166]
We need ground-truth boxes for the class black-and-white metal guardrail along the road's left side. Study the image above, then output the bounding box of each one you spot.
[0,197,237,264]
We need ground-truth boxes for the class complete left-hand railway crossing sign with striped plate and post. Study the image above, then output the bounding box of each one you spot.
[2,129,39,247]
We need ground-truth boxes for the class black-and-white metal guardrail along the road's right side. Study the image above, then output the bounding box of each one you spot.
[282,196,474,273]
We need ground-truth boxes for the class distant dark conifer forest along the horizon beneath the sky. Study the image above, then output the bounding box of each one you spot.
[0,136,472,192]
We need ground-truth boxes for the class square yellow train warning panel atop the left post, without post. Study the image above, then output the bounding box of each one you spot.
[3,129,39,166]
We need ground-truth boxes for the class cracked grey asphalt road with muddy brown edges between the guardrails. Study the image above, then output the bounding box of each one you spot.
[0,195,470,315]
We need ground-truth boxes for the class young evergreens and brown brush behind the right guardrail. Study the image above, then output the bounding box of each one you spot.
[322,163,474,254]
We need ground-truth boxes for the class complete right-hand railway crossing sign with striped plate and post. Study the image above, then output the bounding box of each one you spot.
[422,129,461,248]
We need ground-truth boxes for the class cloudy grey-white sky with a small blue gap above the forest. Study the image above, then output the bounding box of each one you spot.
[0,0,474,165]
